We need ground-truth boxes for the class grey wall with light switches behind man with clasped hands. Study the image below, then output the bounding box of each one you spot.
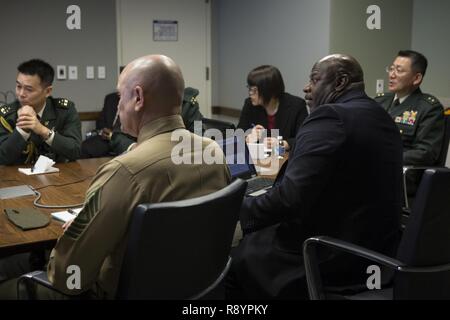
[0,0,118,112]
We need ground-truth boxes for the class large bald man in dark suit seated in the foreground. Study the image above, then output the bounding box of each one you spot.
[227,55,402,299]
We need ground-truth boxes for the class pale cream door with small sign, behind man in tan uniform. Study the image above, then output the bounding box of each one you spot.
[117,0,211,116]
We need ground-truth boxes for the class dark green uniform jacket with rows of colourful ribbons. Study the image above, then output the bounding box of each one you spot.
[375,89,445,166]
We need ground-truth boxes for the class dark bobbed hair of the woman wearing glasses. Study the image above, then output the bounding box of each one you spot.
[247,65,285,103]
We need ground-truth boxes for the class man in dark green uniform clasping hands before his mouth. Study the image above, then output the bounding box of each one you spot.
[0,59,81,165]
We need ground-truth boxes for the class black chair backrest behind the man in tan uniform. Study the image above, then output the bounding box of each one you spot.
[117,180,247,299]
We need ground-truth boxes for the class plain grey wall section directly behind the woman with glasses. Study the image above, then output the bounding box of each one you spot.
[213,0,330,109]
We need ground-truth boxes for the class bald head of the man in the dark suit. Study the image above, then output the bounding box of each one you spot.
[304,54,364,108]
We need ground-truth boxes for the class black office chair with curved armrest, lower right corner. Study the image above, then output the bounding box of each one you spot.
[303,168,450,300]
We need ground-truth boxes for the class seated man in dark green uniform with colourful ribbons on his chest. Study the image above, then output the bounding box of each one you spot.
[375,50,445,195]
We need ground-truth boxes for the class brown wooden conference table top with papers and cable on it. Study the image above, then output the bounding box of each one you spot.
[0,158,111,257]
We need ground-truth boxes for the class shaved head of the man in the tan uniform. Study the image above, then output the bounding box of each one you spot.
[117,55,184,136]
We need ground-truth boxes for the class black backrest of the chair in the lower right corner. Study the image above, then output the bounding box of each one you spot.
[394,168,450,299]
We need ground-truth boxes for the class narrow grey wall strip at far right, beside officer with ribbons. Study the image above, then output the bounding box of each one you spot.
[412,0,450,107]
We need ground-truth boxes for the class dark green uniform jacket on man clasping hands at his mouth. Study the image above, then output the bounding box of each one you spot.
[0,97,81,165]
